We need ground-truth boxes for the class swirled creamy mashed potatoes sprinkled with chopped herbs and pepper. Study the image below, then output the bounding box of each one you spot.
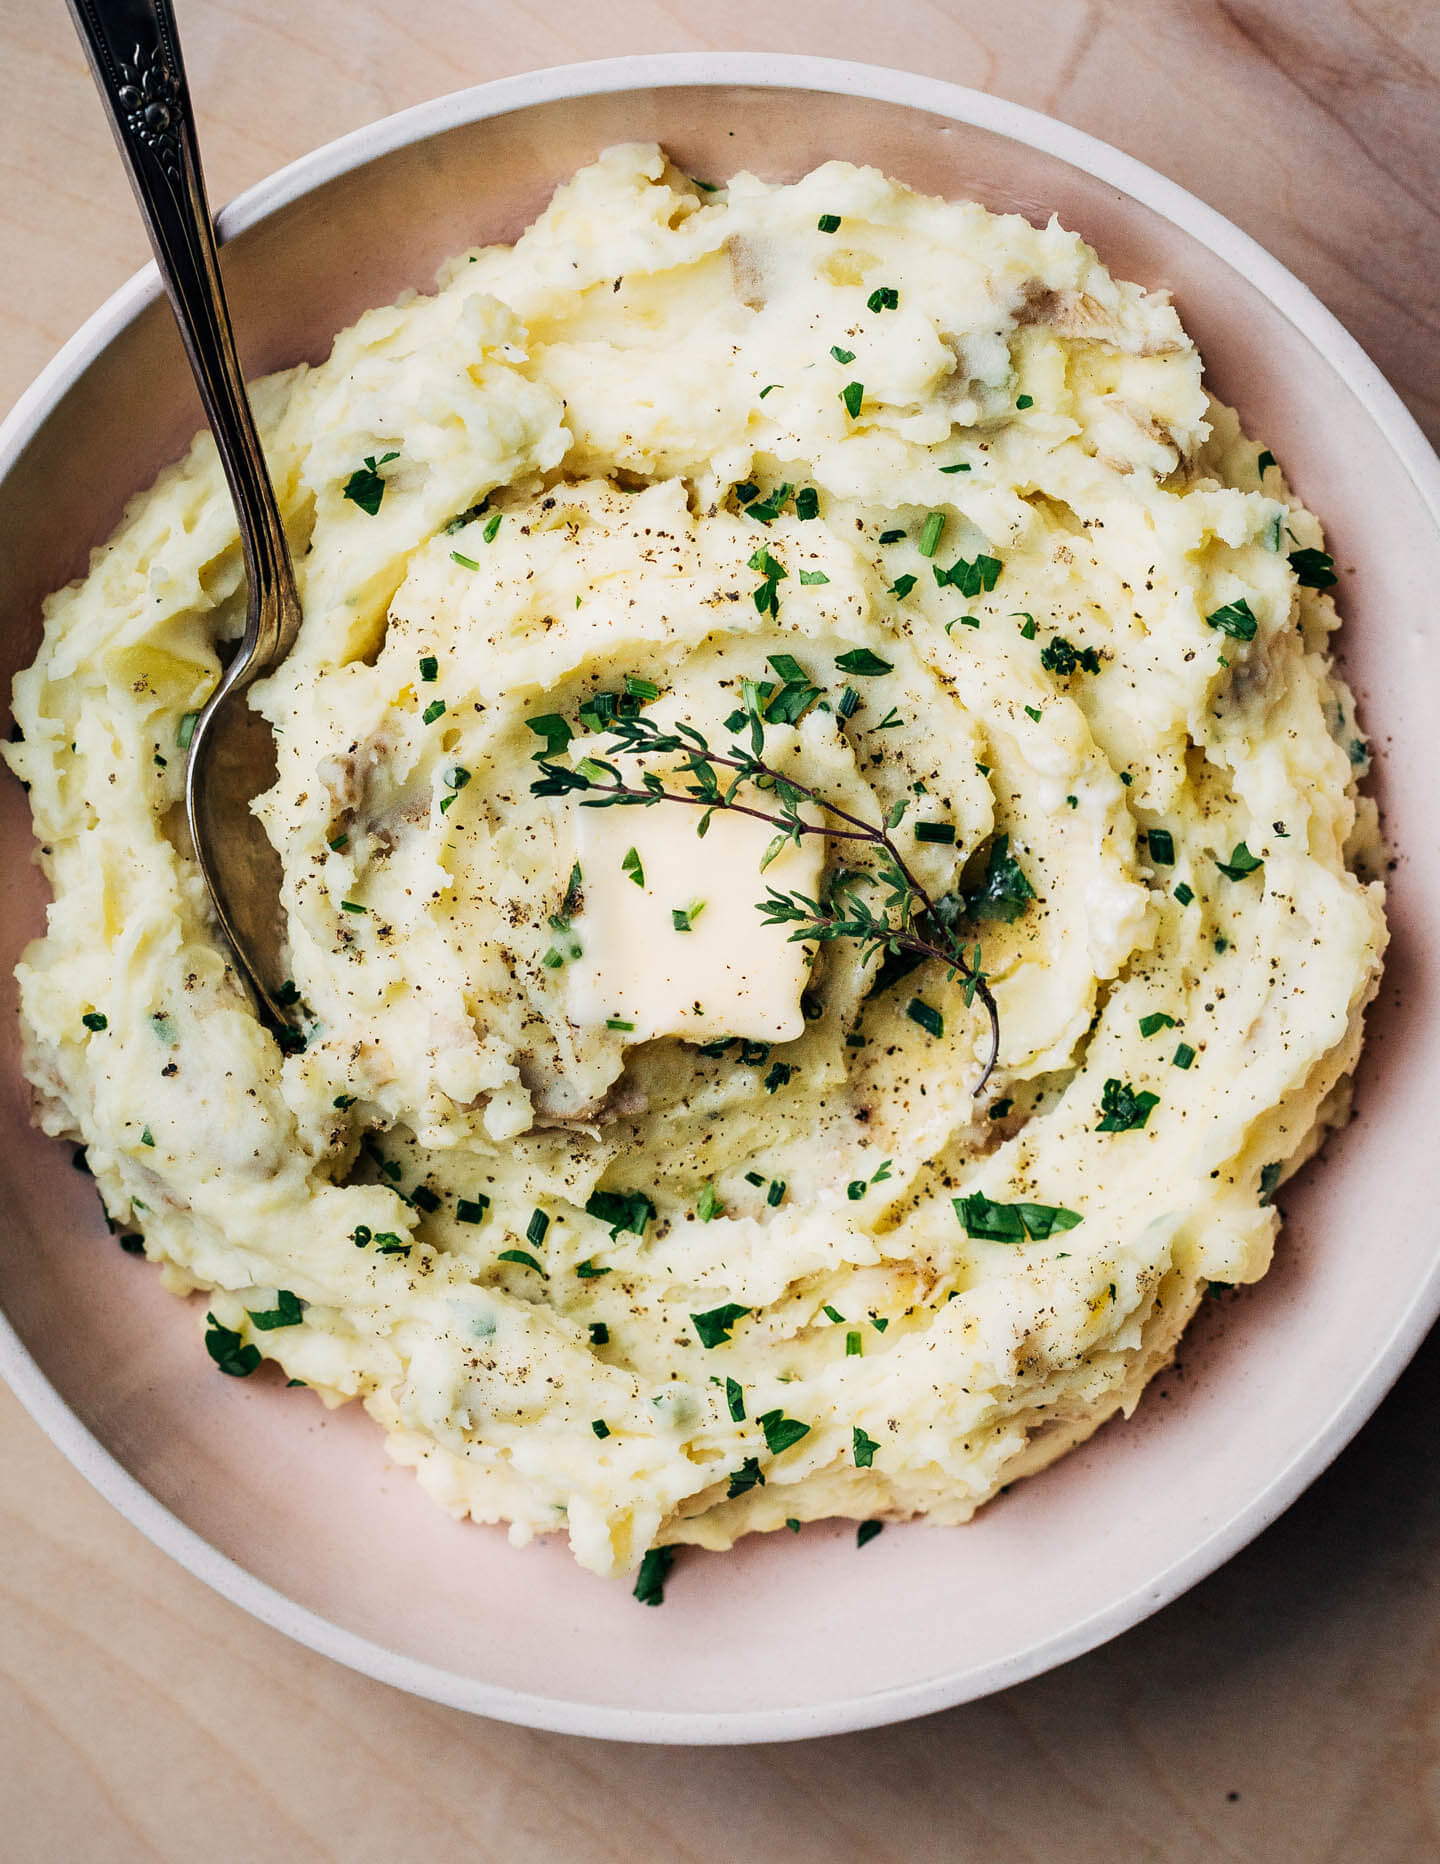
[7,145,1384,1573]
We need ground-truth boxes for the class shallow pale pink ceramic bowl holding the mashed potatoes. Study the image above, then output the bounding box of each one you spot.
[0,54,1440,1741]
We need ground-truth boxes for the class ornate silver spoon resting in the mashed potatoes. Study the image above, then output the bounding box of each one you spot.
[67,0,300,1046]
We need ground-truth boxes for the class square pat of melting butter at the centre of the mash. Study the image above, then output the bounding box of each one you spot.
[566,803,825,1042]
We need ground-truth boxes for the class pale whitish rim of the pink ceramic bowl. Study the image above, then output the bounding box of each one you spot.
[0,52,1440,1745]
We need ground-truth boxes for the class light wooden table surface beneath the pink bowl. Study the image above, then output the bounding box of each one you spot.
[0,0,1440,1864]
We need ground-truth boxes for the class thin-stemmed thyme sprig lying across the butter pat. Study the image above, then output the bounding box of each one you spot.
[531,708,1000,1094]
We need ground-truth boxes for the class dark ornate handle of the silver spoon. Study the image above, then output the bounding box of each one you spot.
[67,0,298,671]
